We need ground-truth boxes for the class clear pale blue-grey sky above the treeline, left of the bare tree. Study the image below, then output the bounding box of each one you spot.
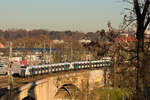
[0,0,124,32]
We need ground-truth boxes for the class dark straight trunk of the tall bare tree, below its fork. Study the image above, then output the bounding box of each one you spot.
[136,25,145,100]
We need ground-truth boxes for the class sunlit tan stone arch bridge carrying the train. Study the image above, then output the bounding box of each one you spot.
[0,69,109,100]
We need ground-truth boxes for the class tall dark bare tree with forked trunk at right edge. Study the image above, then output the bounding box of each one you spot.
[123,0,150,100]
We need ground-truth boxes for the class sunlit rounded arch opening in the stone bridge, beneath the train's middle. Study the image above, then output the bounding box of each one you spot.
[55,84,81,100]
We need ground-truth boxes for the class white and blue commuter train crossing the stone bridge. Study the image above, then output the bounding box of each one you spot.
[19,59,111,77]
